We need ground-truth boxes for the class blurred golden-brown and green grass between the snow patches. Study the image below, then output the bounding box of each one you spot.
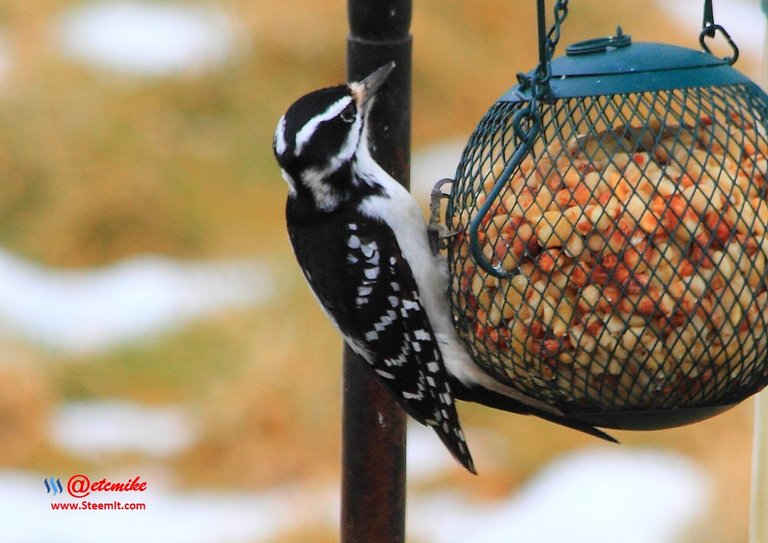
[0,0,754,543]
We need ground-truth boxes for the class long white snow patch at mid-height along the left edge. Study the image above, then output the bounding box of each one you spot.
[0,249,274,353]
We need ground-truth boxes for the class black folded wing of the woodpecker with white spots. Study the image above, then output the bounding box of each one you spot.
[291,207,474,472]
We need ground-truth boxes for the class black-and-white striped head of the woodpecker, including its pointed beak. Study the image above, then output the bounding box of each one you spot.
[273,62,395,208]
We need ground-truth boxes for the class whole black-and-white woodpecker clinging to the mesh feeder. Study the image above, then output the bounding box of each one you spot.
[274,63,606,472]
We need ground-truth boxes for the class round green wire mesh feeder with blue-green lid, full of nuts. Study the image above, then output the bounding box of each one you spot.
[446,0,768,429]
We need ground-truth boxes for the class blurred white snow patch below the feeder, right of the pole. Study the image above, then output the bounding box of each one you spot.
[408,449,710,543]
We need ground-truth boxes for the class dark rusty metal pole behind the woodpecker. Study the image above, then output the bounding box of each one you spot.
[341,0,412,543]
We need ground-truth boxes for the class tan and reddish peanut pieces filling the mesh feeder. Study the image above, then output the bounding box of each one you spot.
[451,112,768,411]
